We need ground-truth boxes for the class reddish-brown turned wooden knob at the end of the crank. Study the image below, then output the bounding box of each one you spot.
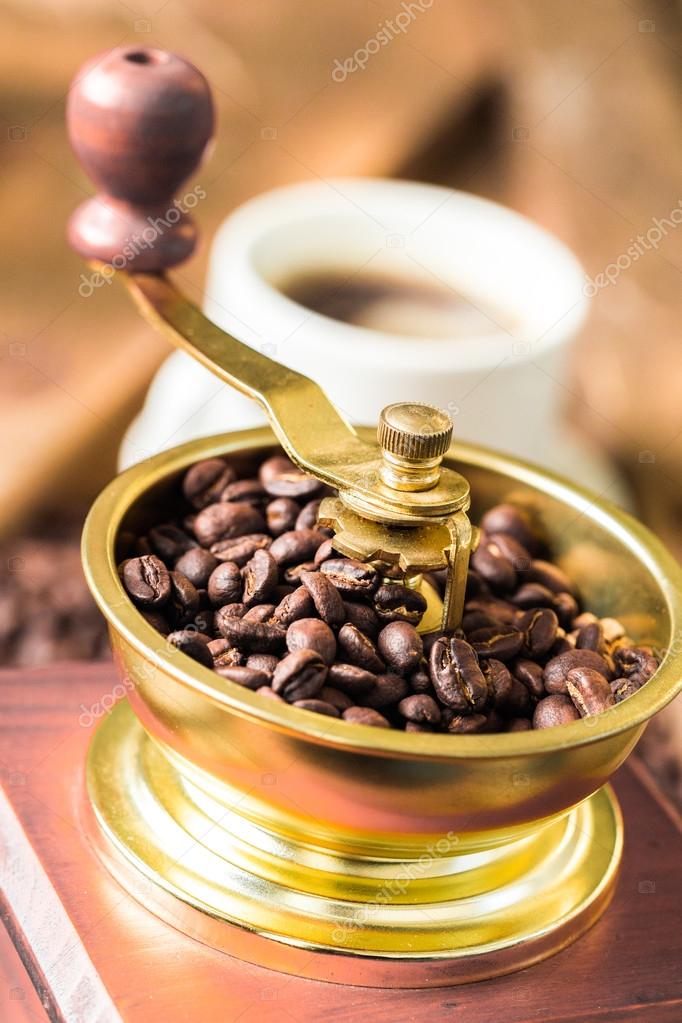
[66,46,215,271]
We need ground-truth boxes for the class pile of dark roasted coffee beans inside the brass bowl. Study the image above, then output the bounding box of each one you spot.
[120,455,658,735]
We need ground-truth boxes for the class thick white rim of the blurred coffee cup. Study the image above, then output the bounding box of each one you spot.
[207,177,589,371]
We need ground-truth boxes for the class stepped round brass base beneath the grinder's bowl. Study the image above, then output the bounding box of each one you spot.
[88,701,623,987]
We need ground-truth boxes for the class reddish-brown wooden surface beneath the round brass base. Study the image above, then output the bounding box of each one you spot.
[0,664,682,1023]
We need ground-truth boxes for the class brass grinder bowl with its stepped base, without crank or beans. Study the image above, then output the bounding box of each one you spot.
[83,429,682,987]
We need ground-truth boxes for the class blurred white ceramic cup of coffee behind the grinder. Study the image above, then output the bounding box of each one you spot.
[121,178,612,499]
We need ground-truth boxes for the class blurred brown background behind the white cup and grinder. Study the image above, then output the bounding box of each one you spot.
[0,0,682,797]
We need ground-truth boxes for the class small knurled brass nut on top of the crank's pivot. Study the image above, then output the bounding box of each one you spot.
[376,401,452,490]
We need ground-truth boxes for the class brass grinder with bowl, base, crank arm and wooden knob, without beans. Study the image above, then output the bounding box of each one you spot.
[69,47,682,987]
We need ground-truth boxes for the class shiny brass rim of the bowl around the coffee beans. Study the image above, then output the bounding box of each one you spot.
[82,427,682,760]
